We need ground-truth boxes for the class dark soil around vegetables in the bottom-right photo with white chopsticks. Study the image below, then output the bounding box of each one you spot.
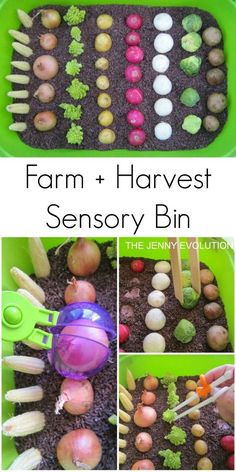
[120,377,233,470]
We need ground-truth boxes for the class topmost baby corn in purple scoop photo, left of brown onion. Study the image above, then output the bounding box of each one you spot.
[28,238,51,278]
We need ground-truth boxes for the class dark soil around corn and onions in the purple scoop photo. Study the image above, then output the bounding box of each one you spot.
[15,243,117,470]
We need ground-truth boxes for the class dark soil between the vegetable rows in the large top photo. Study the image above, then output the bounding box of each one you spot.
[13,5,227,151]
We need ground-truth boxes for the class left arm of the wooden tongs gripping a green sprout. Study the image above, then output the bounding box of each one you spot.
[169,238,184,304]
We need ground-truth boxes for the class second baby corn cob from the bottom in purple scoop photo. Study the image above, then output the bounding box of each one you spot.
[2,411,45,438]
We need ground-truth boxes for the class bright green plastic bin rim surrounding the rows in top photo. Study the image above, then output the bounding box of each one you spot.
[0,0,236,157]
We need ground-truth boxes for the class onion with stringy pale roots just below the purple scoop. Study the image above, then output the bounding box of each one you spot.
[55,379,94,415]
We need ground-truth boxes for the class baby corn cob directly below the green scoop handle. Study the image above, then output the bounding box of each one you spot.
[2,356,45,375]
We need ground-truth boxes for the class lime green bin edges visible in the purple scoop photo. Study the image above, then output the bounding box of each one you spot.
[2,238,111,470]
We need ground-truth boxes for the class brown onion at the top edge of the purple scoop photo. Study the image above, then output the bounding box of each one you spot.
[67,238,101,277]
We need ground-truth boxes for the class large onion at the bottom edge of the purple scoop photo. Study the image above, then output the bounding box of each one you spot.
[57,429,102,470]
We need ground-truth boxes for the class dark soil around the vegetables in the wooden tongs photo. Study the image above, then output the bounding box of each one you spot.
[120,257,232,352]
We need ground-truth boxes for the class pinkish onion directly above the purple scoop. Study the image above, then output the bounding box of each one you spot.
[64,277,96,305]
